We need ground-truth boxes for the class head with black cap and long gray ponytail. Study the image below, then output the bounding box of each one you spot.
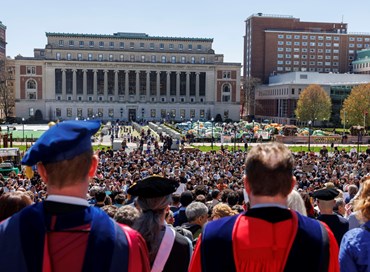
[127,176,179,262]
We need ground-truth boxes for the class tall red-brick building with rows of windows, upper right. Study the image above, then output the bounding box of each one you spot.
[243,13,370,84]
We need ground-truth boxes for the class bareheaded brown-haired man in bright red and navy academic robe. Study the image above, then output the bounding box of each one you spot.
[189,143,339,272]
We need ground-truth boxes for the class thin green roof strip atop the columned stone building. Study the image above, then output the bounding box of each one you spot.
[46,32,213,42]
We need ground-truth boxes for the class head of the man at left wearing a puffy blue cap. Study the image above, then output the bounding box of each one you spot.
[22,120,100,194]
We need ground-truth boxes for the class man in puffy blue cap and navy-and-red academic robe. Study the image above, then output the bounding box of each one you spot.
[0,120,150,272]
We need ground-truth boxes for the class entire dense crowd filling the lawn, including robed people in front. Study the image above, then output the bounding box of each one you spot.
[0,121,370,271]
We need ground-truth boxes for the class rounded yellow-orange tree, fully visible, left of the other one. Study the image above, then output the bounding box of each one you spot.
[295,84,332,121]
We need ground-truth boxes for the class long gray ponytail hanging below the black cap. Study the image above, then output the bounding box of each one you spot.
[133,195,172,262]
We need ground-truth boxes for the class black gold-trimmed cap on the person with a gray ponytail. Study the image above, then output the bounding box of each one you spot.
[127,176,179,198]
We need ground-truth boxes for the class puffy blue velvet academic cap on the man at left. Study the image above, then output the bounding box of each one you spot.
[22,120,100,166]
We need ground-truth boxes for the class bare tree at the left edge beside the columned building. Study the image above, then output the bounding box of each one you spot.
[0,60,15,120]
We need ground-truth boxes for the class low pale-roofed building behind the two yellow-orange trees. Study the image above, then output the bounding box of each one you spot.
[255,72,370,125]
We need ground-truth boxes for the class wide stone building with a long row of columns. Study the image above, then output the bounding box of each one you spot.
[15,33,241,121]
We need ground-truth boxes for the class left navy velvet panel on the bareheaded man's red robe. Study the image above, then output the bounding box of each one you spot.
[201,215,240,272]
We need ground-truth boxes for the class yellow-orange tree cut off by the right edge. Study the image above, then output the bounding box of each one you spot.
[340,84,370,127]
